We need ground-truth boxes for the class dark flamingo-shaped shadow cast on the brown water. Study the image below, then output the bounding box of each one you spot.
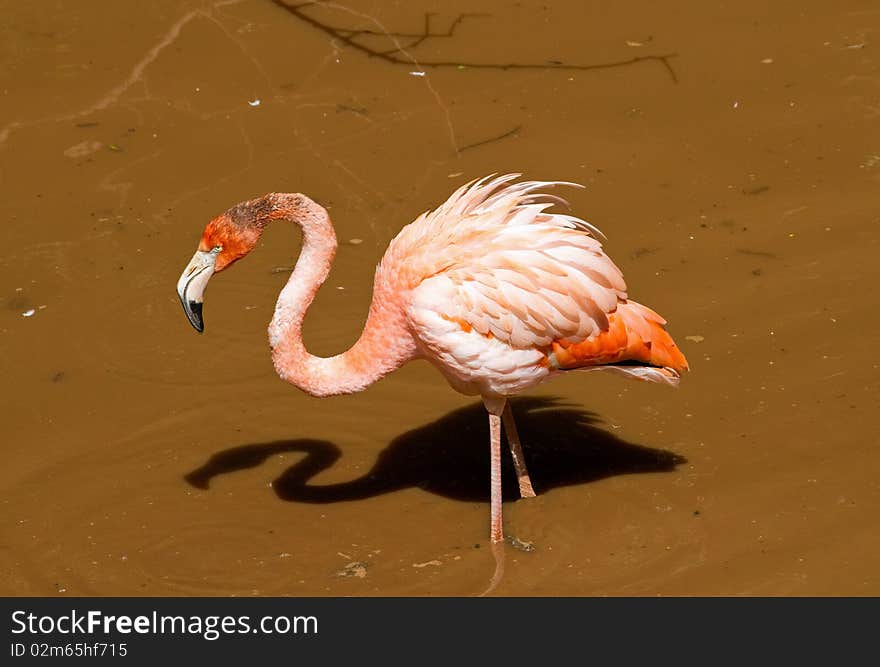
[184,397,686,503]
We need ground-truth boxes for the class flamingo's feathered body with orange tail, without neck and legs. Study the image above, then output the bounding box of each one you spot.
[376,175,687,397]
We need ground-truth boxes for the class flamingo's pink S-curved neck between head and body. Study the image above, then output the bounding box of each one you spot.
[266,194,416,396]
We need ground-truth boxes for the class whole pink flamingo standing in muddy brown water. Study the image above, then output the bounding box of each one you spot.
[177,174,688,545]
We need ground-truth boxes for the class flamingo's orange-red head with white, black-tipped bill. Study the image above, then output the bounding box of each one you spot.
[177,207,265,333]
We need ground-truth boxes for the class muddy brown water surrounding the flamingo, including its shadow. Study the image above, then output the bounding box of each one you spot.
[0,0,880,595]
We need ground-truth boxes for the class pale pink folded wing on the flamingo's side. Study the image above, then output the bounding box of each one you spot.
[414,204,626,349]
